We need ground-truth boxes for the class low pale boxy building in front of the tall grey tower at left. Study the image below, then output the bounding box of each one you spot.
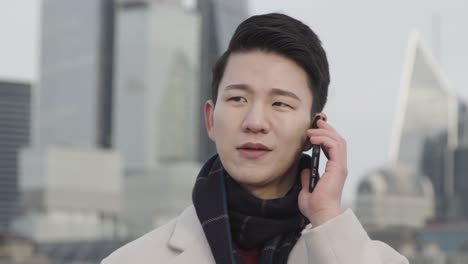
[14,146,126,242]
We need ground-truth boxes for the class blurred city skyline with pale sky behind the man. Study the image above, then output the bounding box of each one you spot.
[0,0,468,264]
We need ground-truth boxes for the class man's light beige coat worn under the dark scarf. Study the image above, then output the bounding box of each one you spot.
[102,206,408,264]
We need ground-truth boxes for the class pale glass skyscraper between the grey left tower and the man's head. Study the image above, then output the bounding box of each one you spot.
[113,1,201,174]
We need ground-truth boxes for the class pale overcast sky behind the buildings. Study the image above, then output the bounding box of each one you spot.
[0,0,468,203]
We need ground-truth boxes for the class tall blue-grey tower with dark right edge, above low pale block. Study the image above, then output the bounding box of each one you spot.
[33,0,114,148]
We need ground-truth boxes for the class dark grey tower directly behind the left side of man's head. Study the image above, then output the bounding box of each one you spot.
[198,0,248,162]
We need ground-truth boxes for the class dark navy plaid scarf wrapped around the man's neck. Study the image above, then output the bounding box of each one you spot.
[192,155,310,264]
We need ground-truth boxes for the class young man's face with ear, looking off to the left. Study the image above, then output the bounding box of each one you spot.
[205,51,312,198]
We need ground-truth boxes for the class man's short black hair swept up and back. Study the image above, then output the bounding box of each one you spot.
[211,13,330,114]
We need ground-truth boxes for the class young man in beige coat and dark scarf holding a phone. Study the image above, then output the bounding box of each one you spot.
[103,14,408,264]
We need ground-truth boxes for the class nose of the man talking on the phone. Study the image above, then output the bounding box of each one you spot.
[242,104,270,134]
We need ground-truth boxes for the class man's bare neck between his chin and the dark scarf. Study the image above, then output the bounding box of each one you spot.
[241,162,299,200]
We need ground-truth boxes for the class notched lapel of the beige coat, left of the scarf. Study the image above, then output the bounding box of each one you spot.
[168,205,215,264]
